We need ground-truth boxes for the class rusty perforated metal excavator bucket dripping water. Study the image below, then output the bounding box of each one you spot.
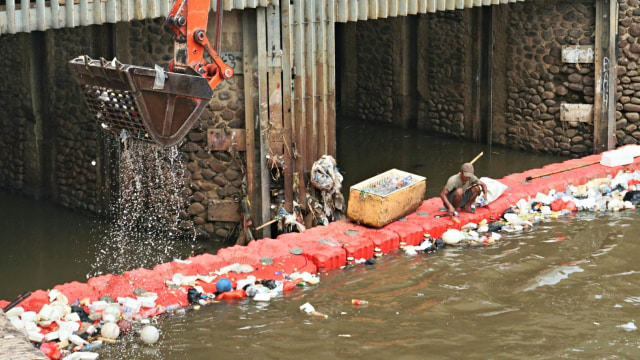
[69,56,213,146]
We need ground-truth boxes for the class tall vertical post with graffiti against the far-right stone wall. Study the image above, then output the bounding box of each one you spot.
[593,0,618,154]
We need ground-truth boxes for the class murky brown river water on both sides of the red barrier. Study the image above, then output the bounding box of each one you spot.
[5,119,640,360]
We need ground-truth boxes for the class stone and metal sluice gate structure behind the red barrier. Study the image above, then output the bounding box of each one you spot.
[0,0,640,243]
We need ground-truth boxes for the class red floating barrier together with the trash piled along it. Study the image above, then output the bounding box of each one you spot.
[0,148,640,360]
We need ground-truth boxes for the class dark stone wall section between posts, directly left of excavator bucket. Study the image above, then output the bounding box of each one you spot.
[51,28,99,213]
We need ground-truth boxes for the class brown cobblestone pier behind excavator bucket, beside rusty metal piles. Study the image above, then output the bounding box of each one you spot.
[129,14,245,240]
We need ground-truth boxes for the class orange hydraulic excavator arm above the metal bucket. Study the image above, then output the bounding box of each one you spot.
[167,0,233,90]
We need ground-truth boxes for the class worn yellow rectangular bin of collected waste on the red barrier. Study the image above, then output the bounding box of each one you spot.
[347,169,427,228]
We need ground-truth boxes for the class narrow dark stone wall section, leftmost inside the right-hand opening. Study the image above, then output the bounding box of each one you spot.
[355,19,394,123]
